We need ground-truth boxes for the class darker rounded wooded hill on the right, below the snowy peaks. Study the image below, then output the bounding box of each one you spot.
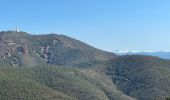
[106,55,170,100]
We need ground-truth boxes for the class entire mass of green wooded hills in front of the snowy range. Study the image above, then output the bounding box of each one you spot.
[0,31,170,100]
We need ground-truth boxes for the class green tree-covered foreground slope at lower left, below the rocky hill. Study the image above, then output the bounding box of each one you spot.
[0,65,133,100]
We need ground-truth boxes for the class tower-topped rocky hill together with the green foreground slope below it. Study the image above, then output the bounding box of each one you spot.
[0,31,133,100]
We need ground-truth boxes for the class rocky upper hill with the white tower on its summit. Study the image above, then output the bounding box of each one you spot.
[0,31,114,67]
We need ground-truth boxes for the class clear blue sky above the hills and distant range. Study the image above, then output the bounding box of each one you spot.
[0,0,170,51]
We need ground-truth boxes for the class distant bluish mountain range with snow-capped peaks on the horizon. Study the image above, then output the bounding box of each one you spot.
[113,50,170,59]
